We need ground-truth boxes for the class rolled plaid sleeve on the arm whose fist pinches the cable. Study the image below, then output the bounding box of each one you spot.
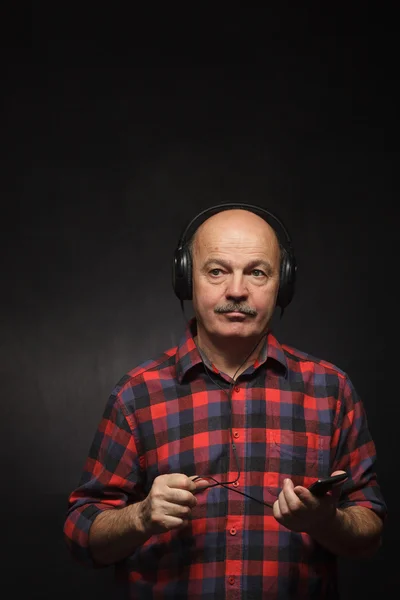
[64,380,144,567]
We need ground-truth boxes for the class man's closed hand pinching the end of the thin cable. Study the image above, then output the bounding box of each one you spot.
[140,473,209,535]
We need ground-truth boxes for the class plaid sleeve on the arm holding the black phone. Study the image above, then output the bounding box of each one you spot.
[331,375,387,518]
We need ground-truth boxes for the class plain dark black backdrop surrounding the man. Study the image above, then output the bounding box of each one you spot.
[0,3,400,600]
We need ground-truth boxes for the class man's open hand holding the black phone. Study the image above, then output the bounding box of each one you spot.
[273,471,344,535]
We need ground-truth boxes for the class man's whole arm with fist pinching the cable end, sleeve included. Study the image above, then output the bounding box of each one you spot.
[64,385,209,567]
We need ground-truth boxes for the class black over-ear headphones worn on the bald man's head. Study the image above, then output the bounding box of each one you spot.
[172,203,297,311]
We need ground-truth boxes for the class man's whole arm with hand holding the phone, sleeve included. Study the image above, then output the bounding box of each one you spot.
[274,378,386,558]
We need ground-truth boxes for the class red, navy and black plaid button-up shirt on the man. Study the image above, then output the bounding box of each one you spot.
[64,321,386,600]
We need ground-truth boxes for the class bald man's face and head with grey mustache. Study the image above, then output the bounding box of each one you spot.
[193,210,280,338]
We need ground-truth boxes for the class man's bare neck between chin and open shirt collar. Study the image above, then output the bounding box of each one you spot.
[194,327,265,378]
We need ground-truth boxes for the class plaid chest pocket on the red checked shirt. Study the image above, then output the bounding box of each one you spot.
[266,429,322,495]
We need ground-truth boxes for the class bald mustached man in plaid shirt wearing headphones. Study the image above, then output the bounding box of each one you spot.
[64,205,386,600]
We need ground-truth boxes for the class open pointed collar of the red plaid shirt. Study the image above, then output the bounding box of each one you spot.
[175,318,288,383]
